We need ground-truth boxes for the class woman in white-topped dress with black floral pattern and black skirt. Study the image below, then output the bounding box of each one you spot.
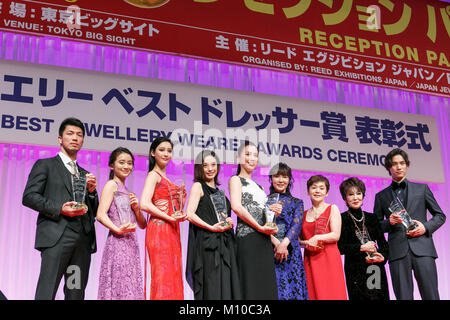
[229,141,281,300]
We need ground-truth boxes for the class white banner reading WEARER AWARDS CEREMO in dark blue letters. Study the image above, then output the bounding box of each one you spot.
[0,60,444,182]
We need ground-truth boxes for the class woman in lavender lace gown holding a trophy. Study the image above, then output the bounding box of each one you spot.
[97,147,146,300]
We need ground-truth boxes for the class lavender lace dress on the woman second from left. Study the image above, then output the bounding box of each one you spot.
[98,181,144,300]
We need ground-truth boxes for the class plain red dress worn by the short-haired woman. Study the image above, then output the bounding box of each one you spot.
[302,205,347,300]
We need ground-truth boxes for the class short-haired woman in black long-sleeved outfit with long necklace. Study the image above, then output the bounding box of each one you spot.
[338,177,389,300]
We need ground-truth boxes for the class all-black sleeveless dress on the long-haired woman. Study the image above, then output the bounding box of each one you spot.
[186,182,241,300]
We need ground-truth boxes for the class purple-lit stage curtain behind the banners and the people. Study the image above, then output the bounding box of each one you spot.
[0,33,450,299]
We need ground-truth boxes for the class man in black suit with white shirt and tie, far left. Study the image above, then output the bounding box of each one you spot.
[22,118,98,300]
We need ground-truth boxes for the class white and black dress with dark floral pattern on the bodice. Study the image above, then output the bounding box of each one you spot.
[236,177,278,300]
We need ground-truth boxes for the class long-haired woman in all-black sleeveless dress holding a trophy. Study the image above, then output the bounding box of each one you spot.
[186,150,241,300]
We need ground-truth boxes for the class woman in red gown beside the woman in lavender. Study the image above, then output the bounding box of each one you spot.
[141,137,186,300]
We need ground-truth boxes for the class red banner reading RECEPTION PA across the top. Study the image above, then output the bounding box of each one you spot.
[0,0,450,97]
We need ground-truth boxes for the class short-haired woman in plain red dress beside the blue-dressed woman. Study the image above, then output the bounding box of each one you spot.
[300,175,347,300]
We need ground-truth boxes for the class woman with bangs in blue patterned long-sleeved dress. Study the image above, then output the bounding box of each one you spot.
[270,163,308,300]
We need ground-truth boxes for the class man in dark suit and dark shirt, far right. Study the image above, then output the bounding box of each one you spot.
[374,149,446,300]
